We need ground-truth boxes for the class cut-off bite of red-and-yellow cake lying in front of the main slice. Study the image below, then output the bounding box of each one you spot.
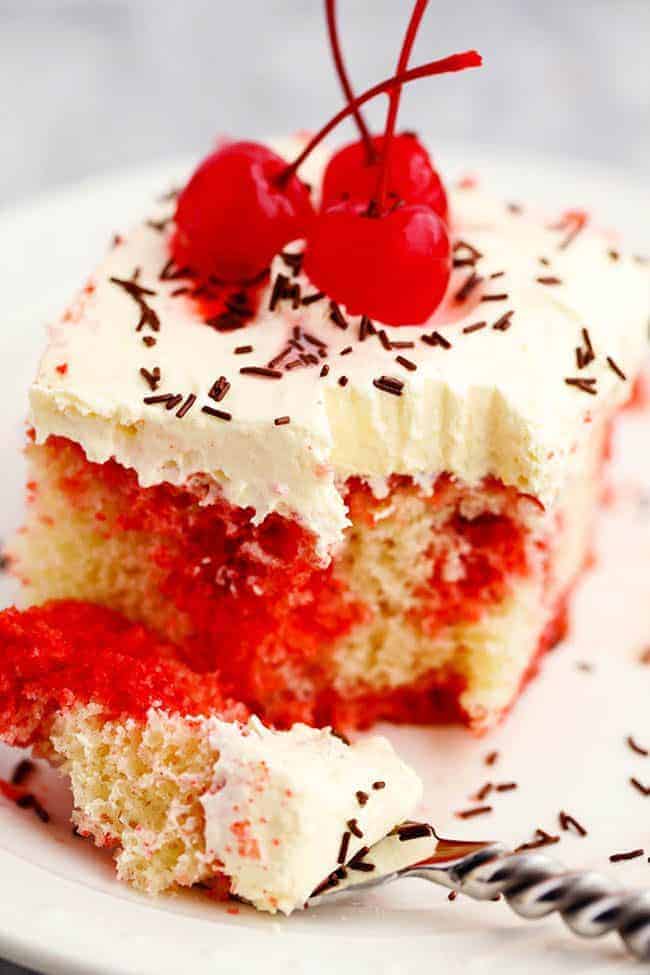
[0,602,421,914]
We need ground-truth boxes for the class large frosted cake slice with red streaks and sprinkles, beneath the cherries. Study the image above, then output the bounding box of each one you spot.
[13,146,648,730]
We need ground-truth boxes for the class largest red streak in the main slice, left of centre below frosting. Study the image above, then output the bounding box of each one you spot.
[50,440,366,725]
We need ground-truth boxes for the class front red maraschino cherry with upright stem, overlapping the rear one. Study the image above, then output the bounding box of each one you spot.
[303,0,470,325]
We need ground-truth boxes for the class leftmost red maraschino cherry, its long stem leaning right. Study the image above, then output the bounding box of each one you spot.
[172,51,481,283]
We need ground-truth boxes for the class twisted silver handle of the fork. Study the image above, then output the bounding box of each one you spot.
[408,844,650,961]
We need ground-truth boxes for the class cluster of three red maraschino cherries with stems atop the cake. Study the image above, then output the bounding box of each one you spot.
[172,0,481,325]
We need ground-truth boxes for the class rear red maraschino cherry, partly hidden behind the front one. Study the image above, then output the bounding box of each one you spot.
[321,0,449,221]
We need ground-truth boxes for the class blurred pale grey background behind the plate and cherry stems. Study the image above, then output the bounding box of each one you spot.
[0,0,650,975]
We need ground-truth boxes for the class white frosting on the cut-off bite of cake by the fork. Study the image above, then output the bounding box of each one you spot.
[201,718,421,914]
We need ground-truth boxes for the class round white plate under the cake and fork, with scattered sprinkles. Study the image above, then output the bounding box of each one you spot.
[0,149,650,975]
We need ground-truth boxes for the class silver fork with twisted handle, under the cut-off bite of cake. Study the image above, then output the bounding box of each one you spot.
[309,824,650,961]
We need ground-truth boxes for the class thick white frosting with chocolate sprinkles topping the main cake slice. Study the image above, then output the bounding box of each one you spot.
[31,141,650,559]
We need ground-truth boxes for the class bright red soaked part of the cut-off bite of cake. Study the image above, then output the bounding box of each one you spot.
[0,601,245,746]
